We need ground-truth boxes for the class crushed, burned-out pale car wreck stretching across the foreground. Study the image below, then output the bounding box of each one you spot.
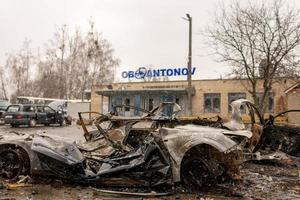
[0,100,298,188]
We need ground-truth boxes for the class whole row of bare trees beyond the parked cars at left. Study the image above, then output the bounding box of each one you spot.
[0,21,119,101]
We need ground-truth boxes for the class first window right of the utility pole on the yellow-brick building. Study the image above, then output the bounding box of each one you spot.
[204,93,221,113]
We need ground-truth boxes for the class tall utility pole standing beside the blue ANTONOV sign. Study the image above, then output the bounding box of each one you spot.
[183,14,194,116]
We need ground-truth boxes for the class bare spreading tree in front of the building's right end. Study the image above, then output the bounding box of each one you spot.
[207,1,300,113]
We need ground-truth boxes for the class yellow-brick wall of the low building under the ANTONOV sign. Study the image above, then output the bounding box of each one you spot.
[91,79,299,117]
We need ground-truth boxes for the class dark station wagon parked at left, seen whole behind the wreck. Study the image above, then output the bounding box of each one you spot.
[5,104,65,127]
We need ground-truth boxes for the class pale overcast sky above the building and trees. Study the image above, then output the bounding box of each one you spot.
[0,0,299,81]
